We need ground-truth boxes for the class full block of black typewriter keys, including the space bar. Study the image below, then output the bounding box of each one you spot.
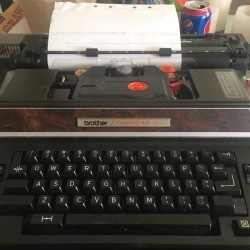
[0,137,250,242]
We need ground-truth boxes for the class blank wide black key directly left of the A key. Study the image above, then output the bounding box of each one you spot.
[4,180,29,194]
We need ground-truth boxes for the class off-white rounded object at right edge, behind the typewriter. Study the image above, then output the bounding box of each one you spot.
[231,5,250,43]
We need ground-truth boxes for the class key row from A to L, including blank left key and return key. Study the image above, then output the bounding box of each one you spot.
[4,179,241,196]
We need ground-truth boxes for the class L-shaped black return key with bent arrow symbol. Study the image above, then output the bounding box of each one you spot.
[215,167,241,197]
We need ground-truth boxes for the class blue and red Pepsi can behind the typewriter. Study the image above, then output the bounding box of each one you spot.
[180,1,212,34]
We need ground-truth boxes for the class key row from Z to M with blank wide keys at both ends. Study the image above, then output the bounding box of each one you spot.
[0,195,247,216]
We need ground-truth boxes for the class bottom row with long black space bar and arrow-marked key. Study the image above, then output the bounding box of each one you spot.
[23,213,213,235]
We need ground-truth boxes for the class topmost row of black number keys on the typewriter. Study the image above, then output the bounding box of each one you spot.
[24,149,236,165]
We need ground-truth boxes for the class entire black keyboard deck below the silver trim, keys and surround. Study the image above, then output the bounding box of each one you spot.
[0,138,250,249]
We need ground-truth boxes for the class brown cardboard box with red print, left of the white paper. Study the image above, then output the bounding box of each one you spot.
[0,0,96,34]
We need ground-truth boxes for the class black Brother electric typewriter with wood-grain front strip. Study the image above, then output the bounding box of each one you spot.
[0,31,250,249]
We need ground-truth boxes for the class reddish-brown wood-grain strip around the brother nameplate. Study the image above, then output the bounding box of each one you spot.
[0,108,250,132]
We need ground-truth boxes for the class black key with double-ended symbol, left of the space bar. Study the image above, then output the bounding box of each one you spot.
[29,213,63,234]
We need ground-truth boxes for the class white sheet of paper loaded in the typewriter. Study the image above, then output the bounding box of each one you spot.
[48,3,181,69]
